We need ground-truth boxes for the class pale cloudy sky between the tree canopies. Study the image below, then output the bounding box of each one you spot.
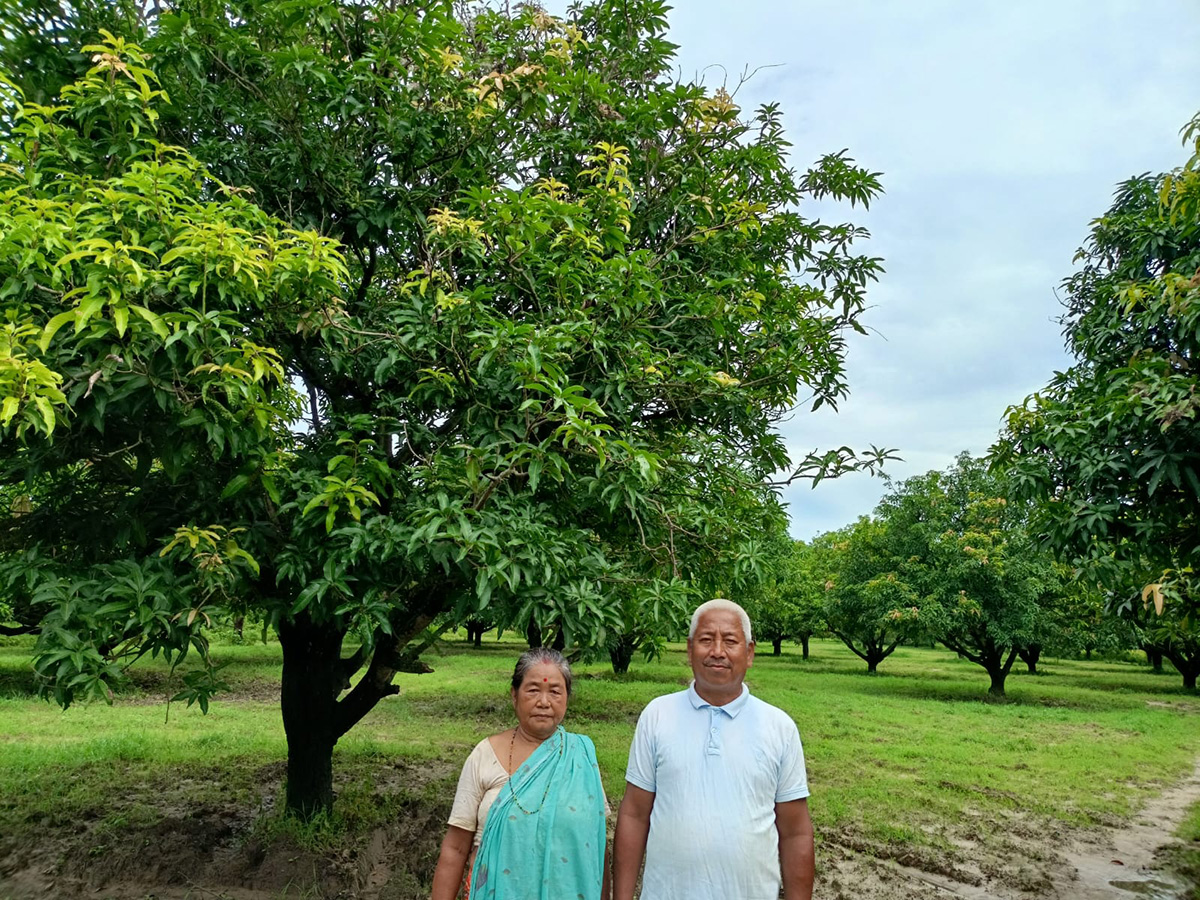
[585,0,1200,539]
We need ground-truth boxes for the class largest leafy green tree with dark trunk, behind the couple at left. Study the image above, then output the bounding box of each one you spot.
[0,0,882,816]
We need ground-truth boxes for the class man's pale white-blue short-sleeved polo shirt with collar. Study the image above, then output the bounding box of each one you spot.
[625,684,809,900]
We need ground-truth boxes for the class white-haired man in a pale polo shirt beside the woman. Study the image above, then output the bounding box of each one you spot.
[613,600,812,900]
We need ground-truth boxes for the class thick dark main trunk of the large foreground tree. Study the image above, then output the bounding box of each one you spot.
[278,616,346,820]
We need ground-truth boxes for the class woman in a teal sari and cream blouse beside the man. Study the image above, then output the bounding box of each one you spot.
[432,648,608,900]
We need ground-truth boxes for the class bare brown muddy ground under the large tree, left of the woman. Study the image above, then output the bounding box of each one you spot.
[0,763,455,900]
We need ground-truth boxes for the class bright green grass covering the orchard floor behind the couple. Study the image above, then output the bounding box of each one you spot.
[0,638,1200,897]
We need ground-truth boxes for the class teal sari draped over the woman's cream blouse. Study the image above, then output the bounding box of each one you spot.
[470,726,606,900]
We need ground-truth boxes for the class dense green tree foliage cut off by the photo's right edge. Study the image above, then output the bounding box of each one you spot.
[992,139,1200,689]
